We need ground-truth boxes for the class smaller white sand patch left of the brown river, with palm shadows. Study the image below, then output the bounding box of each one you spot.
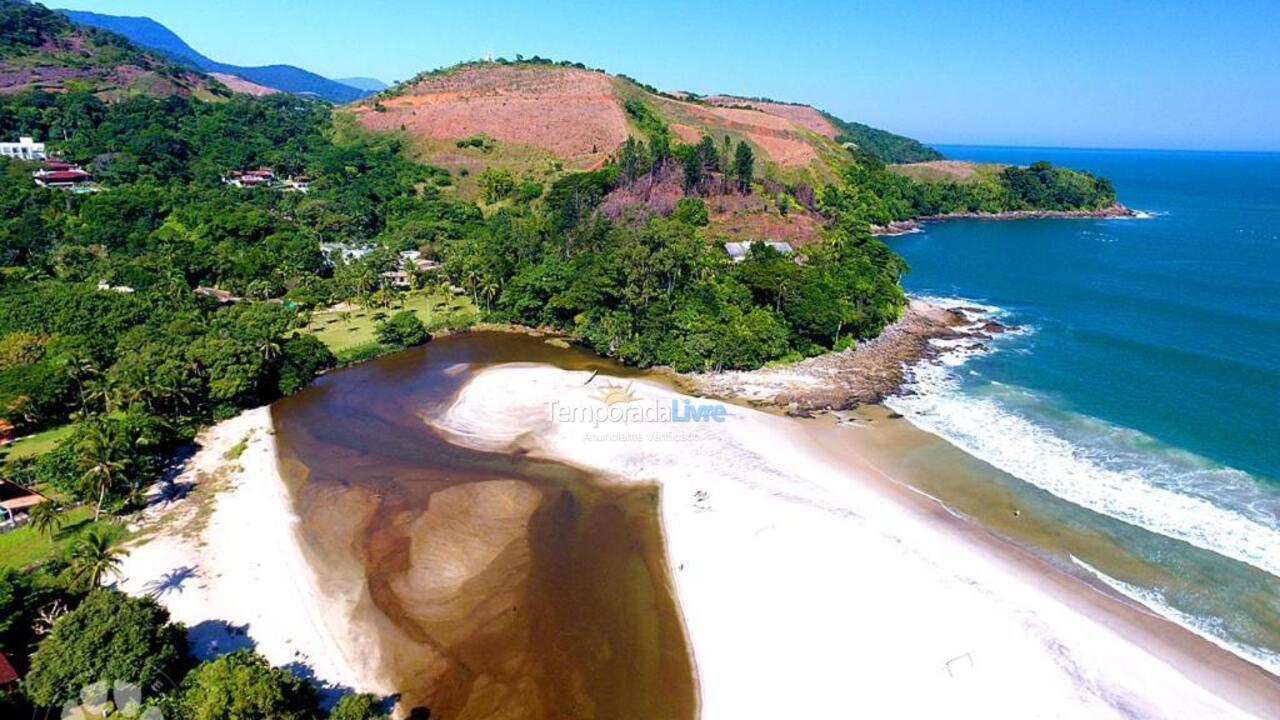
[119,407,390,698]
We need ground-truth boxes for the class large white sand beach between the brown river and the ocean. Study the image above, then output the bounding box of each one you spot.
[429,364,1275,720]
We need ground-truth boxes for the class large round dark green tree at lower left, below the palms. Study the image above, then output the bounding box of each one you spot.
[22,589,187,707]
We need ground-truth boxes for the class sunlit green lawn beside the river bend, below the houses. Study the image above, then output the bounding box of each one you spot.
[306,291,480,359]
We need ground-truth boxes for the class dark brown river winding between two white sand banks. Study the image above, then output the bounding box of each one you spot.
[273,333,698,720]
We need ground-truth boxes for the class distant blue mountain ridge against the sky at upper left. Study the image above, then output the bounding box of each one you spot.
[59,10,385,104]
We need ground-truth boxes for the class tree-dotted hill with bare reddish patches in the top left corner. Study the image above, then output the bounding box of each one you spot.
[0,0,228,99]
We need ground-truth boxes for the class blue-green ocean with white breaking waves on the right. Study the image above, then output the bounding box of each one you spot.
[887,146,1280,674]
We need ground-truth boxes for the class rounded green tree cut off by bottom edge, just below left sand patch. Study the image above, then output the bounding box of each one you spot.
[178,650,316,720]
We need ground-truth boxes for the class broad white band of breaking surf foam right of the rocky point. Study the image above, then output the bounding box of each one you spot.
[886,299,1280,577]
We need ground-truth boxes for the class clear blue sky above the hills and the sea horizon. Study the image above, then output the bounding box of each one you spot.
[46,0,1280,150]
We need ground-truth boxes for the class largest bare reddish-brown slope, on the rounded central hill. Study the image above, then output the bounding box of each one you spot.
[355,65,627,168]
